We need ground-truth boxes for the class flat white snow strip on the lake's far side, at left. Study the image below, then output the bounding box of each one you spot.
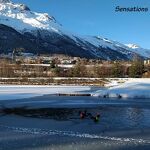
[0,85,90,100]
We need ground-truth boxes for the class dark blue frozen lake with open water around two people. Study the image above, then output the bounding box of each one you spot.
[0,95,150,150]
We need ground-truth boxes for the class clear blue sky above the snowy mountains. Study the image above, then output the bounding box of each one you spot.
[13,0,150,48]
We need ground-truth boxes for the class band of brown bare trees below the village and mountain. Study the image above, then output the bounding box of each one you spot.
[0,59,150,78]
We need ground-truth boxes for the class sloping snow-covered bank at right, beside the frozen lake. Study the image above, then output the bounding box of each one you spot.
[93,78,150,98]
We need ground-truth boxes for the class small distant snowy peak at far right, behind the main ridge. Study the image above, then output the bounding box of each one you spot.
[126,44,150,58]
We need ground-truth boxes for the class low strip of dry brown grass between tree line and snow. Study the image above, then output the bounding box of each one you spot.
[0,77,106,86]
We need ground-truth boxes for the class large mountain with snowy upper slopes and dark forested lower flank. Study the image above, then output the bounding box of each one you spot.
[0,0,150,60]
